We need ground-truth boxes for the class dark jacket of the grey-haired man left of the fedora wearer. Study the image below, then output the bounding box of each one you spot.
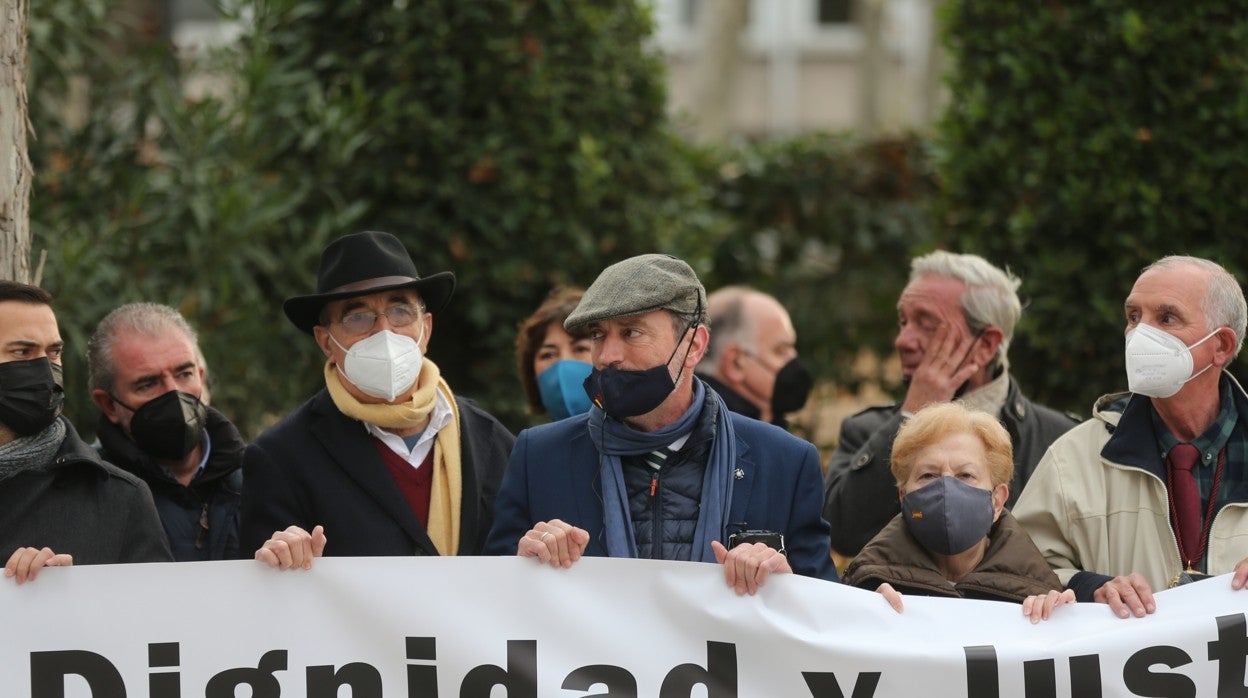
[96,407,250,562]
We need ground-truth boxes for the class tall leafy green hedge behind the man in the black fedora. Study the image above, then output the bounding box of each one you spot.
[30,0,698,435]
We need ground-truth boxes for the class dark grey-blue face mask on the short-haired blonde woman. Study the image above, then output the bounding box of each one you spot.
[901,476,995,556]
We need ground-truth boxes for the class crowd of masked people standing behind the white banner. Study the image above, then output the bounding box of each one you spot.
[0,231,1248,622]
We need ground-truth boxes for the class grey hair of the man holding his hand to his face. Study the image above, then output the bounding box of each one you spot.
[910,250,1022,358]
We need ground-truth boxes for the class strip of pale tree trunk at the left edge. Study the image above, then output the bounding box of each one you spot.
[0,0,34,282]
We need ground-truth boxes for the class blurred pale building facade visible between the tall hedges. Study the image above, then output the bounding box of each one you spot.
[653,0,941,140]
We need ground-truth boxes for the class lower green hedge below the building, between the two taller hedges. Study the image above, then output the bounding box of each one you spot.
[680,134,936,402]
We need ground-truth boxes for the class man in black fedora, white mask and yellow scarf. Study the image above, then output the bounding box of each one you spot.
[241,231,514,568]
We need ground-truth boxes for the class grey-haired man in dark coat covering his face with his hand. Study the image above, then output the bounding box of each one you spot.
[824,251,1077,558]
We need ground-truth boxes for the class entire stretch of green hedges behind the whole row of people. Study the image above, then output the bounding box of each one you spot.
[29,0,1248,435]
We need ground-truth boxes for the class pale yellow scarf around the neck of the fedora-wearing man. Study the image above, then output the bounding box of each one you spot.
[324,358,463,556]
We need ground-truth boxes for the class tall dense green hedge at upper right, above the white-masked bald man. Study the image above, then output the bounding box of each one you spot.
[937,0,1248,415]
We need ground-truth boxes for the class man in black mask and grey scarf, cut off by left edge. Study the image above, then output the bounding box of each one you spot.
[0,281,171,584]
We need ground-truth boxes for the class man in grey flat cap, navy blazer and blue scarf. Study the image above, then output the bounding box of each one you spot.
[485,255,836,594]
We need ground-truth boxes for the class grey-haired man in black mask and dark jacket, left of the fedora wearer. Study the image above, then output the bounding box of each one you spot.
[87,303,245,562]
